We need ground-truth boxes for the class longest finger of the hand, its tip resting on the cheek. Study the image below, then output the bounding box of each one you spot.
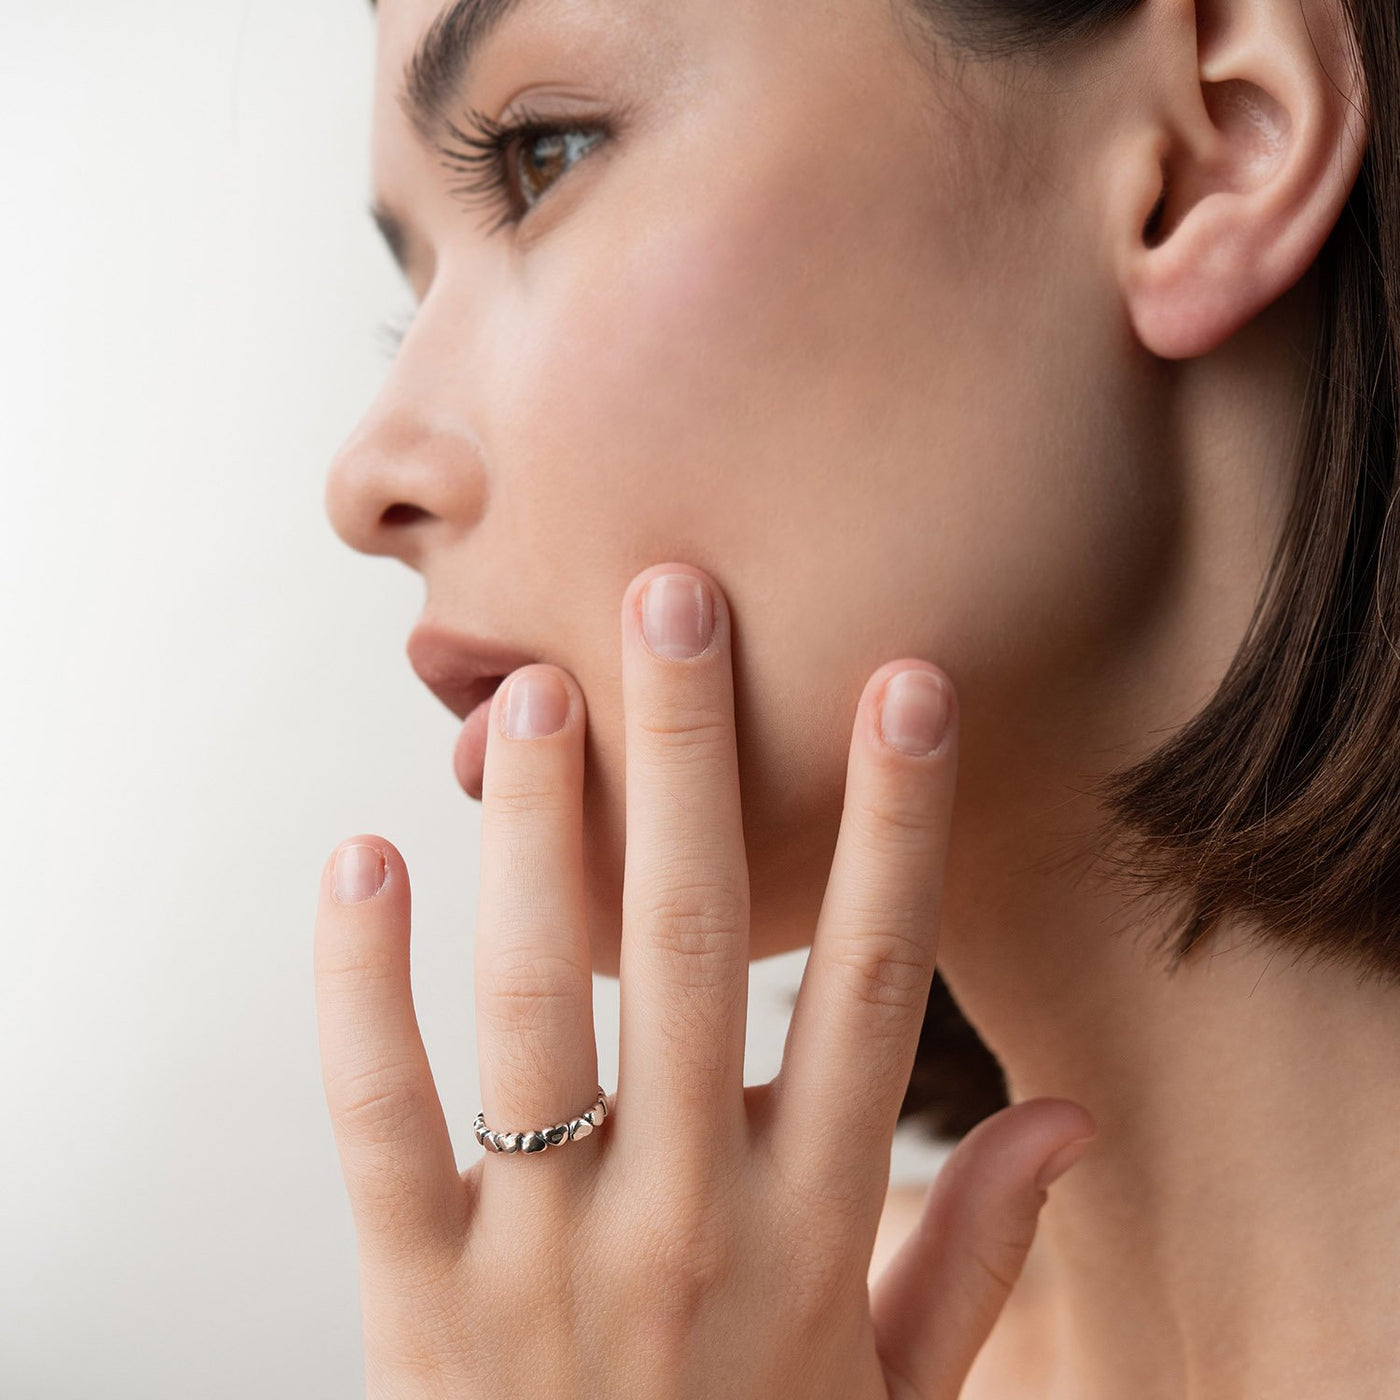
[617,564,749,1159]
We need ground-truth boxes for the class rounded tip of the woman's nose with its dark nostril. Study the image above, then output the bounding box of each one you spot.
[325,393,484,573]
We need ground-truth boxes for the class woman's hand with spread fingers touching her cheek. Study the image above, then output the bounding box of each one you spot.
[315,566,1095,1400]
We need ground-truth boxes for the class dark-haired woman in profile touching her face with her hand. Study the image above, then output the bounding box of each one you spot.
[316,0,1400,1400]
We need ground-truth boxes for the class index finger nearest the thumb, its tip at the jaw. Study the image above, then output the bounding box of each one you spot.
[769,659,958,1211]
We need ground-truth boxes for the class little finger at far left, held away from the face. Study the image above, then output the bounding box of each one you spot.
[315,837,466,1270]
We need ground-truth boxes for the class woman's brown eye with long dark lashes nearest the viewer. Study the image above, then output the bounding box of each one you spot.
[438,109,612,234]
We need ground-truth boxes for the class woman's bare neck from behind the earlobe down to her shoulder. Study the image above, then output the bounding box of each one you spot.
[939,267,1400,1400]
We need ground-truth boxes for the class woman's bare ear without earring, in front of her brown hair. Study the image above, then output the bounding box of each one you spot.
[1117,0,1369,360]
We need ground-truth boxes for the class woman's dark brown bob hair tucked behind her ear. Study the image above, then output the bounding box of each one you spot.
[900,0,1400,1138]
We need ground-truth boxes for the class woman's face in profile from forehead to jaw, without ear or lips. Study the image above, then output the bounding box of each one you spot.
[326,0,1173,972]
